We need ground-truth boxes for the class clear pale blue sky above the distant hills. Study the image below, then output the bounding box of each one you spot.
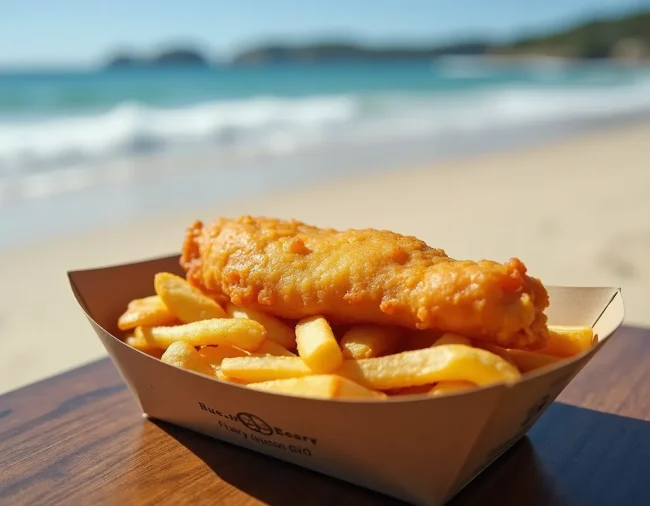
[0,0,650,67]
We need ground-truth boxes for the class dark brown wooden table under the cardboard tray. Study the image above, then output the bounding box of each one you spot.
[0,327,650,506]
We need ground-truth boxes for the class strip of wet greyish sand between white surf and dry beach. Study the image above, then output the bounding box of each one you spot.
[0,111,650,253]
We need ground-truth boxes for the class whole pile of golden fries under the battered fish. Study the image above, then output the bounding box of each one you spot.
[117,272,597,399]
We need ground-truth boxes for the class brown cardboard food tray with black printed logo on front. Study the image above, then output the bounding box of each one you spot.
[68,256,624,505]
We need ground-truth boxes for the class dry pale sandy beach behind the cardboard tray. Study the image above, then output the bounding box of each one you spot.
[0,119,650,392]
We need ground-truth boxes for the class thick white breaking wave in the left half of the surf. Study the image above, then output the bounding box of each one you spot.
[0,96,355,174]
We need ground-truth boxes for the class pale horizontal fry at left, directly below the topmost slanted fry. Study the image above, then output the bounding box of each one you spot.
[142,318,266,351]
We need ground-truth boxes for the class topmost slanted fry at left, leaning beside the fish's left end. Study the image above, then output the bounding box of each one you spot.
[154,272,227,323]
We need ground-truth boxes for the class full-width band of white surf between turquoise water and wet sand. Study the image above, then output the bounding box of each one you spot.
[0,75,650,178]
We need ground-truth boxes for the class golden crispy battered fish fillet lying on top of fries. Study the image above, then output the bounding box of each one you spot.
[181,216,549,348]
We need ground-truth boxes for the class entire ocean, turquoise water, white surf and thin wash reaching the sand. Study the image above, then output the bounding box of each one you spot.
[0,58,650,245]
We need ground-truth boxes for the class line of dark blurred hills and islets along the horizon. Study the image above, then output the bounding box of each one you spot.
[106,12,650,68]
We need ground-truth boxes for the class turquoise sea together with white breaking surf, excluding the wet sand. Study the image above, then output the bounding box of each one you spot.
[0,59,650,174]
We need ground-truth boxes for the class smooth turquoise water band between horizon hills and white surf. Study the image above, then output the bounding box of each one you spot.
[5,60,650,112]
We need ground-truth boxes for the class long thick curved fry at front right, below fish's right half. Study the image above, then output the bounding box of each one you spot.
[336,344,521,390]
